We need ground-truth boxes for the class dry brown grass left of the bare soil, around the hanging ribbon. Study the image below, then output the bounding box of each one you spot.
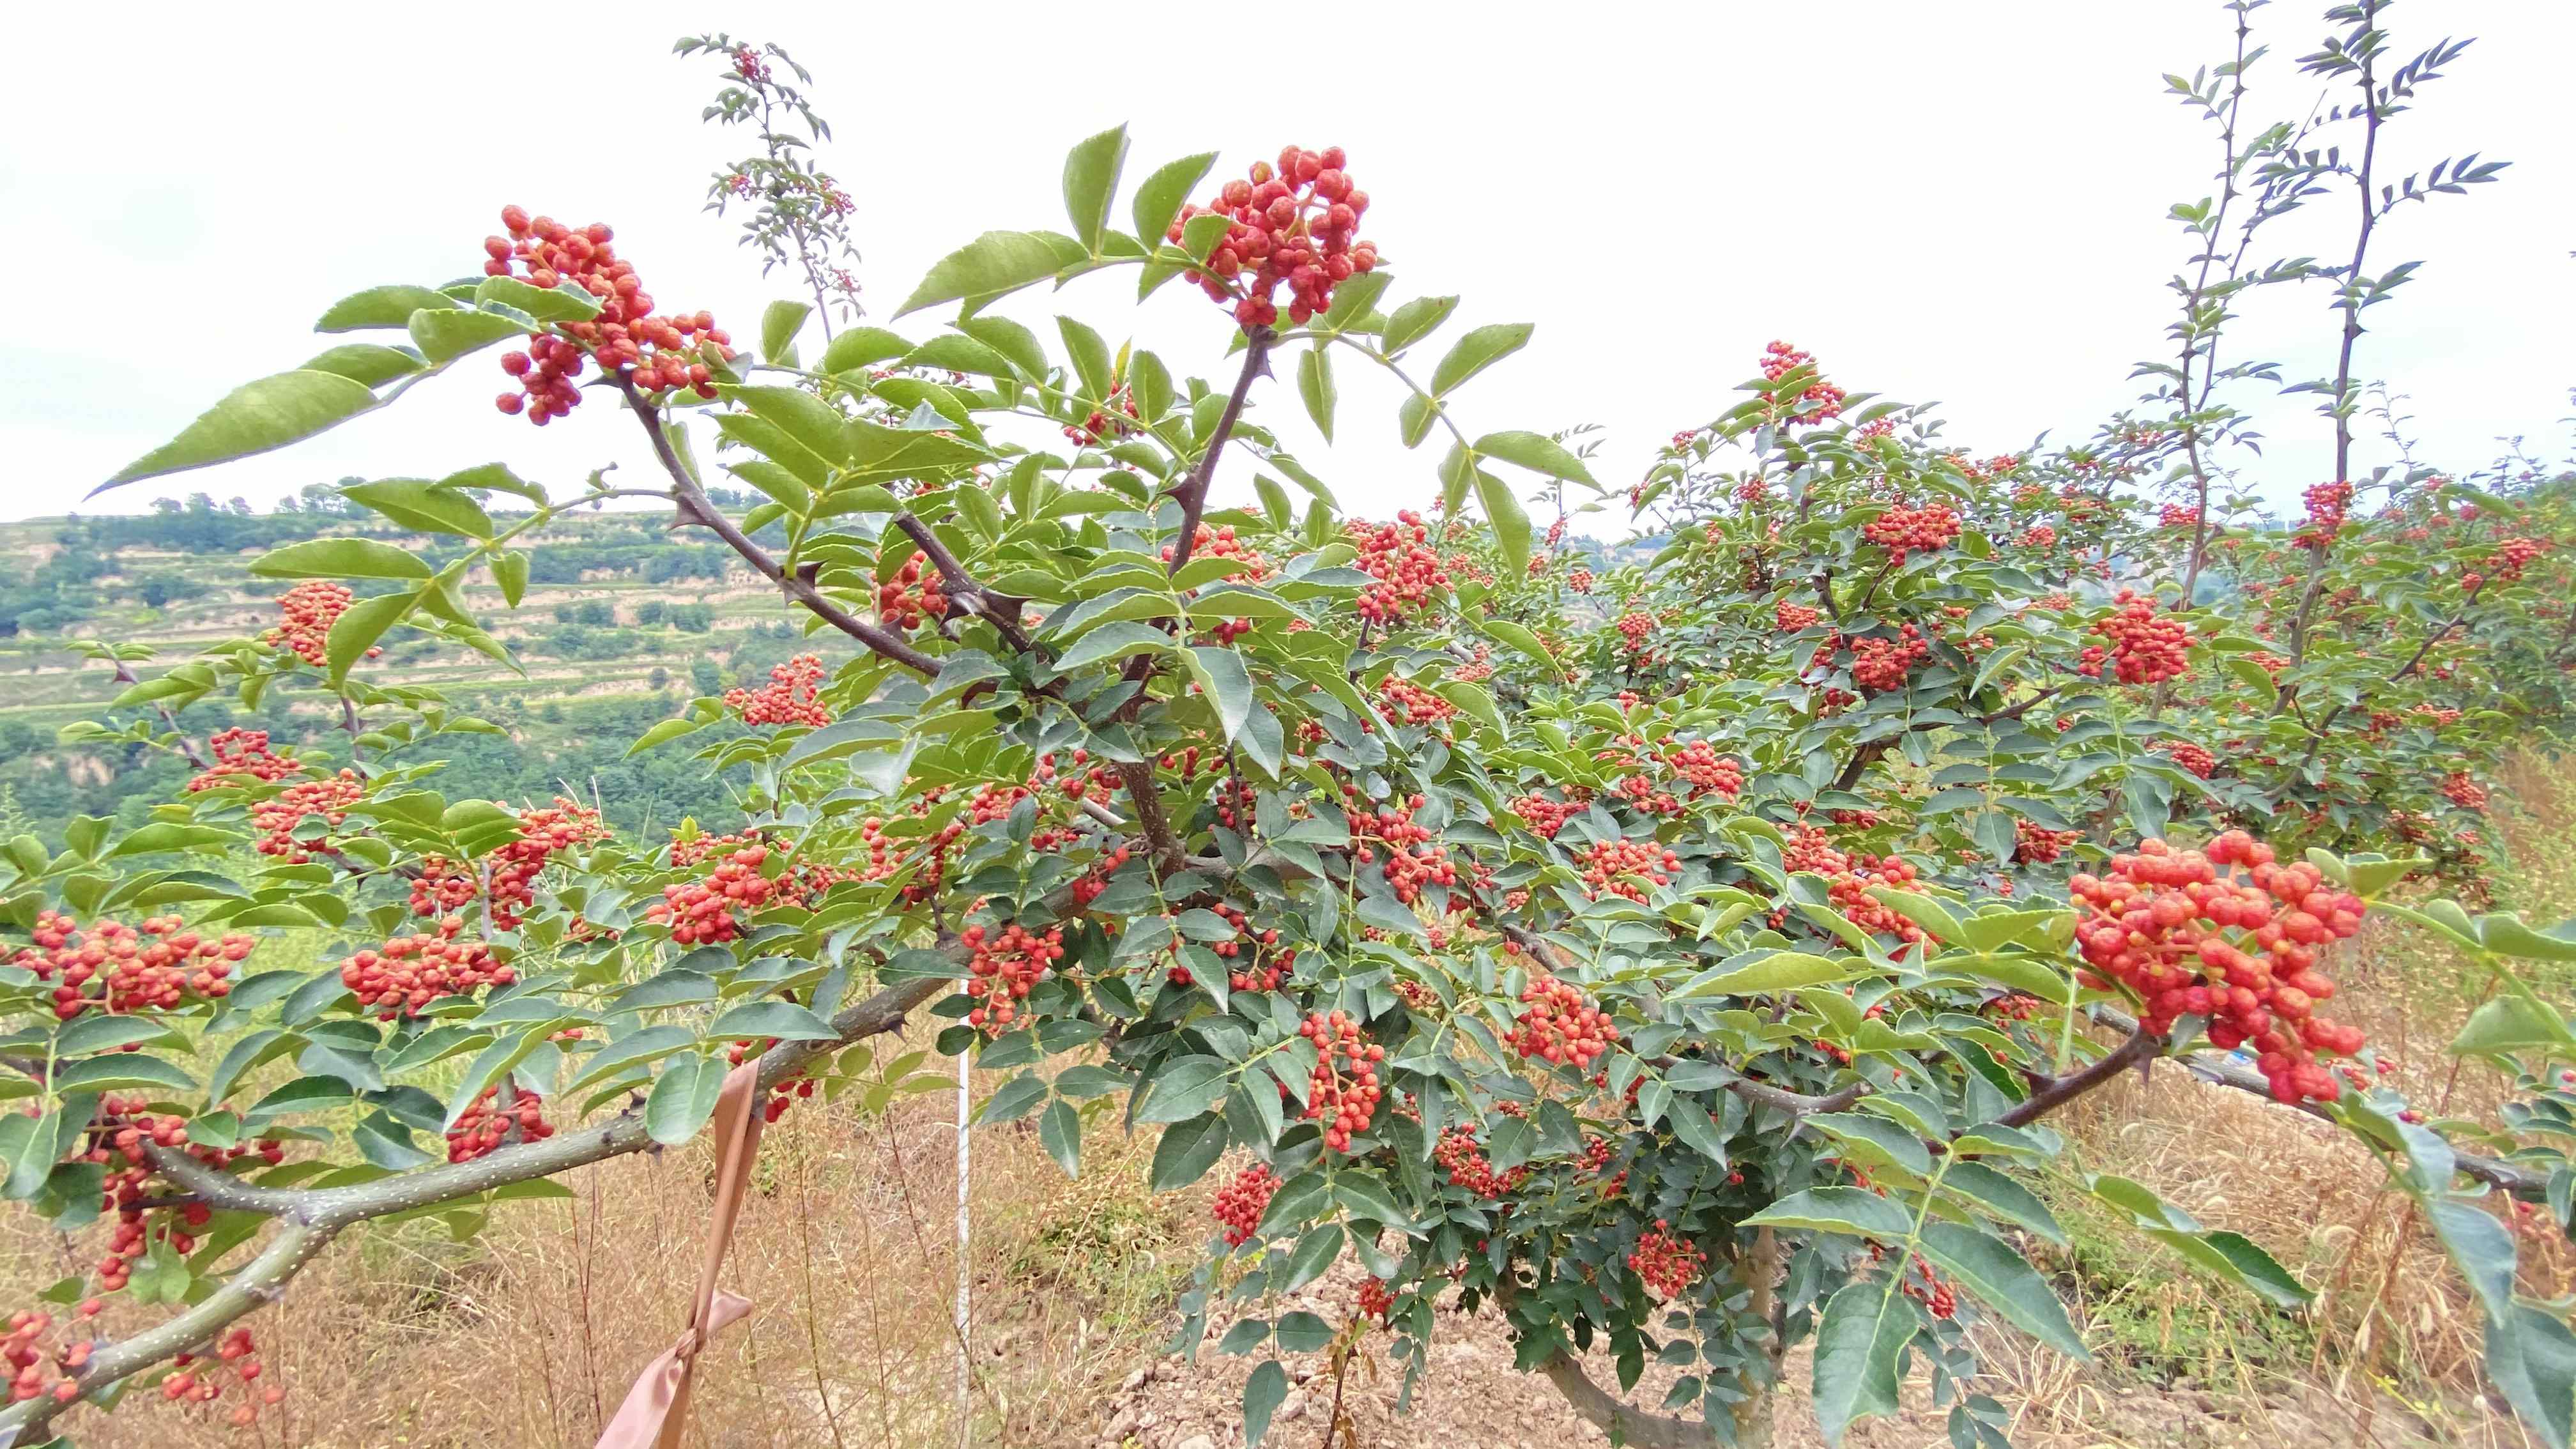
[0,1036,1195,1449]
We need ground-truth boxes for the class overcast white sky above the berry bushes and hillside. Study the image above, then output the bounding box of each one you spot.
[0,0,2576,531]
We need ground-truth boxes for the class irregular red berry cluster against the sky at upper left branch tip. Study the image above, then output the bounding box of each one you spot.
[484,206,734,425]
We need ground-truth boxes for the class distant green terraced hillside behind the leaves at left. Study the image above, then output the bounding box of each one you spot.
[0,490,804,838]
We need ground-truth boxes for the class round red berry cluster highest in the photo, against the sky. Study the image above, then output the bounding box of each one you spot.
[1164,147,1378,333]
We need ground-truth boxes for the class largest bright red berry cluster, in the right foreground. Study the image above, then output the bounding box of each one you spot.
[2069,830,2362,1101]
